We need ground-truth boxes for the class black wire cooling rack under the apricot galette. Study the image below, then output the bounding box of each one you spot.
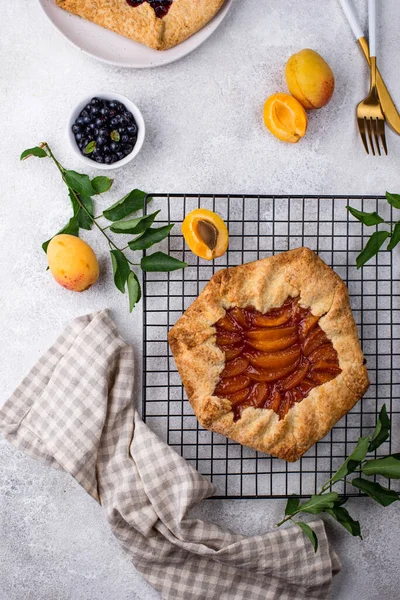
[143,194,400,498]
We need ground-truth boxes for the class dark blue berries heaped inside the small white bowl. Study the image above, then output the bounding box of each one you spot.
[72,98,138,165]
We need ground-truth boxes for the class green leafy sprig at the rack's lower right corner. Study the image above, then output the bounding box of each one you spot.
[277,405,400,552]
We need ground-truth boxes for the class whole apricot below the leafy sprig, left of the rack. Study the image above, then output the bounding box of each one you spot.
[47,233,99,292]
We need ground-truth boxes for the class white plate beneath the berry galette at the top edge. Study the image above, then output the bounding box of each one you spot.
[39,0,233,69]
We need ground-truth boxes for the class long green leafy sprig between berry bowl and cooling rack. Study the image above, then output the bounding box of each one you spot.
[21,142,187,312]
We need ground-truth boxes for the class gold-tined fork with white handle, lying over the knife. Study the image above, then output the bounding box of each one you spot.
[357,0,387,156]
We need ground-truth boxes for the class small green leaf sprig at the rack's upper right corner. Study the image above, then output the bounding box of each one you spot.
[346,192,400,269]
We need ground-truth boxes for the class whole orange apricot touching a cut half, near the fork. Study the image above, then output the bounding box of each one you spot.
[285,48,335,110]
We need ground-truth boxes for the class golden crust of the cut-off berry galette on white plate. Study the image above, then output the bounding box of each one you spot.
[55,0,224,50]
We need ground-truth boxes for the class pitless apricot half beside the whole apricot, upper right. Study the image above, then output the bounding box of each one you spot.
[264,93,308,144]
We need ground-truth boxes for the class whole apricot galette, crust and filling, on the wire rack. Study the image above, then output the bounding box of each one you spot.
[169,248,369,461]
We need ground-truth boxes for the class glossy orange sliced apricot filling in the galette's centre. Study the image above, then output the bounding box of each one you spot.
[214,298,341,421]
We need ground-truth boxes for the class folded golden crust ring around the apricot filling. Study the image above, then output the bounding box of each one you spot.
[168,248,369,462]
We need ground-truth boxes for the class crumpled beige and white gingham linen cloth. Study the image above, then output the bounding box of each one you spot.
[0,311,340,600]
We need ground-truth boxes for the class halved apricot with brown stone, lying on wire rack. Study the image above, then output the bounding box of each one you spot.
[182,208,229,260]
